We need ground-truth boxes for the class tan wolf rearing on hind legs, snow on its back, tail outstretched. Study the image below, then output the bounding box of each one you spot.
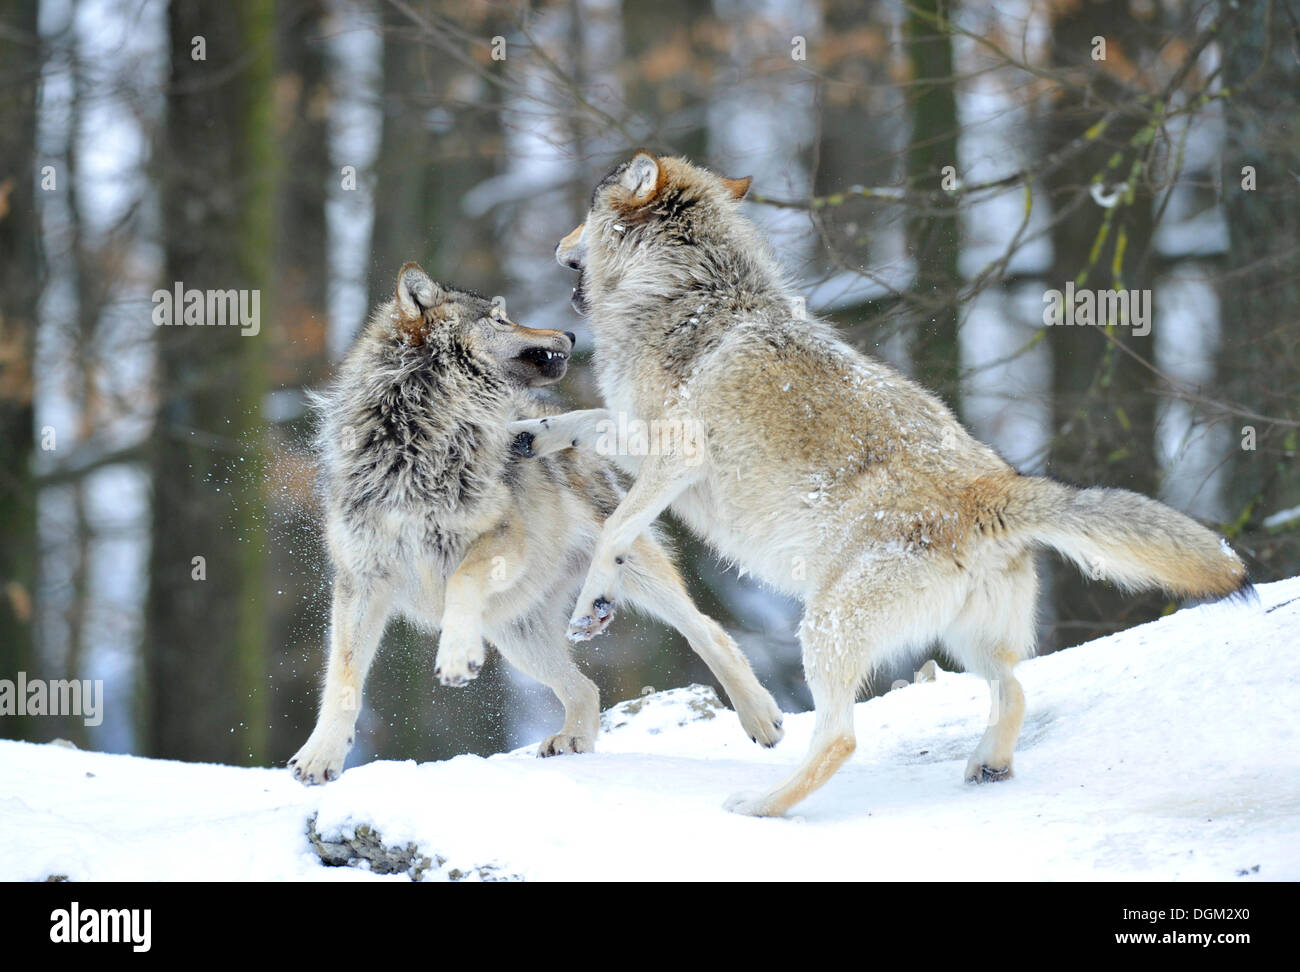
[516,152,1247,816]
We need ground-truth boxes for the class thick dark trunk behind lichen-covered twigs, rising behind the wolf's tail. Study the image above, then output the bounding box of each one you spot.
[1043,0,1166,651]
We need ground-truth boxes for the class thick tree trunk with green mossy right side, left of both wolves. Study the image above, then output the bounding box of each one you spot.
[140,0,276,763]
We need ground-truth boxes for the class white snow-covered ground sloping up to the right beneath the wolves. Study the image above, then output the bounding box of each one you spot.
[0,578,1300,881]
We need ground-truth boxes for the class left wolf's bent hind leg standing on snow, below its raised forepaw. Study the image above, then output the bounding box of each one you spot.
[488,611,601,756]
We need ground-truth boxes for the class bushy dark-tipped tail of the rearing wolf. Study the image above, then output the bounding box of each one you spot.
[1008,476,1252,600]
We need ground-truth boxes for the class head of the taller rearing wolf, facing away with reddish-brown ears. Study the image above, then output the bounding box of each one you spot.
[555,151,774,314]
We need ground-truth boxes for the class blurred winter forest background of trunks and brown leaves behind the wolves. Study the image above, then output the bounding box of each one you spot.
[0,0,1300,764]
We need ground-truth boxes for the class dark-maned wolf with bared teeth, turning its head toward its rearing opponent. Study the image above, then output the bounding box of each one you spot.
[290,264,781,784]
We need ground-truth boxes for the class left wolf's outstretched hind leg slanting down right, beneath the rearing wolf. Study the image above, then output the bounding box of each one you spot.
[621,534,785,746]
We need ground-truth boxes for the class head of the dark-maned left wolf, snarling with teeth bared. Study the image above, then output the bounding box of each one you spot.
[391,262,573,387]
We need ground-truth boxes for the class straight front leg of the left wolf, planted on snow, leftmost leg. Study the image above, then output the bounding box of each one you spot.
[289,572,393,784]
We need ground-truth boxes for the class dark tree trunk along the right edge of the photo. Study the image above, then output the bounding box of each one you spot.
[1219,3,1300,581]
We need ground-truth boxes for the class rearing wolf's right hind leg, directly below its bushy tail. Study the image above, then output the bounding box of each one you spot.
[943,555,1037,784]
